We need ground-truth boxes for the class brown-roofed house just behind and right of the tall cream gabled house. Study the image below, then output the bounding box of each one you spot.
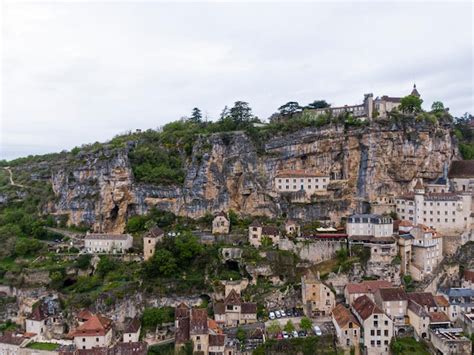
[374,287,408,326]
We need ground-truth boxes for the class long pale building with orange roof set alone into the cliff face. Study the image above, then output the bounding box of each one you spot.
[274,170,330,197]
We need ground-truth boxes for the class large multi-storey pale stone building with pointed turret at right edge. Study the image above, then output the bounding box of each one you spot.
[396,180,472,234]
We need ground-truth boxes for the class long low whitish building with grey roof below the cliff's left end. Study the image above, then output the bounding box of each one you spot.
[84,233,133,254]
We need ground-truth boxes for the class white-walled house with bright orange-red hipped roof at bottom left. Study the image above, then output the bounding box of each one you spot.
[71,315,112,350]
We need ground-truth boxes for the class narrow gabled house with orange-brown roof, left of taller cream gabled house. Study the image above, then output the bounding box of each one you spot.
[331,303,361,349]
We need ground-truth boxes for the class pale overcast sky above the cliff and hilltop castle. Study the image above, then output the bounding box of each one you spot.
[0,1,474,159]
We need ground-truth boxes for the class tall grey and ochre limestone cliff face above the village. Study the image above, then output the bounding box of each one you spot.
[49,123,458,232]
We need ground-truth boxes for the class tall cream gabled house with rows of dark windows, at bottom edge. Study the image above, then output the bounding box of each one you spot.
[351,296,394,355]
